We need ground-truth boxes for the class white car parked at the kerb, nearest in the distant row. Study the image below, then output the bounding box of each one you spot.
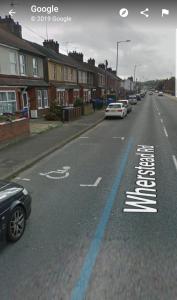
[105,103,127,119]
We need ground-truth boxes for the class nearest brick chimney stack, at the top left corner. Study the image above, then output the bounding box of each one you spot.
[0,16,22,38]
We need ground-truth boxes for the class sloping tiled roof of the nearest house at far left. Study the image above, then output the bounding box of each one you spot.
[0,28,45,57]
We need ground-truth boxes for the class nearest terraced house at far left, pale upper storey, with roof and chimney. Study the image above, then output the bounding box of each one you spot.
[0,17,49,115]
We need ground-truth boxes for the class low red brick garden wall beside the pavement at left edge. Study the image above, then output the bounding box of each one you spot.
[0,118,30,142]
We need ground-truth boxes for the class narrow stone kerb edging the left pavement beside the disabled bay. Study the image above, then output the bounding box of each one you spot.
[2,118,104,180]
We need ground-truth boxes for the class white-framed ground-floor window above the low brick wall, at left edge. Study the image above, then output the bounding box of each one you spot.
[0,91,16,115]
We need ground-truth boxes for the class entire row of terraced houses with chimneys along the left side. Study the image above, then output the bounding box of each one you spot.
[0,16,120,118]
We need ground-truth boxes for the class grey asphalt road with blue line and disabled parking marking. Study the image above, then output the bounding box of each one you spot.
[0,95,177,300]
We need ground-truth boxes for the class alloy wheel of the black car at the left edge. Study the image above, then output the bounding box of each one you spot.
[7,205,26,242]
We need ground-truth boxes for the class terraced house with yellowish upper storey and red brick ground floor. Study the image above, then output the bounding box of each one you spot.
[31,40,79,106]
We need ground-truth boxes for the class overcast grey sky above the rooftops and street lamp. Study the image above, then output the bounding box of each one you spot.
[0,0,177,80]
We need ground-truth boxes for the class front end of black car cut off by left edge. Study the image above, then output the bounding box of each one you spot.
[0,181,31,242]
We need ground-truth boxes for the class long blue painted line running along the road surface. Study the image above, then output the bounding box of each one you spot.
[70,139,133,300]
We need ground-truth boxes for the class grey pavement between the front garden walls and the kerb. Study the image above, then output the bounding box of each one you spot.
[0,111,104,179]
